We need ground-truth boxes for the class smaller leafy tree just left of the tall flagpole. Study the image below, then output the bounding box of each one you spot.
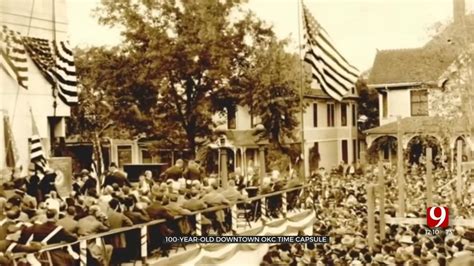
[240,38,311,162]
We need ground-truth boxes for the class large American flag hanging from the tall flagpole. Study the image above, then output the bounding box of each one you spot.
[303,5,359,101]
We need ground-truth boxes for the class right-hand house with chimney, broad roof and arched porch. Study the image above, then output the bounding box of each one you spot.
[365,0,474,162]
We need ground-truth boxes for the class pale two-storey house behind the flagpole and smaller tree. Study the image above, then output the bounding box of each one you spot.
[216,89,364,178]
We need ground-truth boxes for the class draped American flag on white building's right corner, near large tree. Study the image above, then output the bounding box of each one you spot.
[24,37,78,105]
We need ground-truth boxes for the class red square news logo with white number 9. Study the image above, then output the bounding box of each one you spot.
[426,206,454,235]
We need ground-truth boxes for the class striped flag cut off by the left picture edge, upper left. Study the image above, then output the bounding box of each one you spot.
[0,25,28,89]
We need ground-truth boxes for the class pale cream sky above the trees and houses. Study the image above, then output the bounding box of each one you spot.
[66,0,474,71]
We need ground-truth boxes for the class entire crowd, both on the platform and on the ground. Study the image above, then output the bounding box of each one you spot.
[0,156,474,265]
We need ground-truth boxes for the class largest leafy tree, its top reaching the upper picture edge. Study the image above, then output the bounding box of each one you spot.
[93,0,273,156]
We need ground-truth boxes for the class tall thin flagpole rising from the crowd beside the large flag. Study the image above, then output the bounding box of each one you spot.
[298,0,307,182]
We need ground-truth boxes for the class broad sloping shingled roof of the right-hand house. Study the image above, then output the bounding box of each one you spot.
[368,45,458,86]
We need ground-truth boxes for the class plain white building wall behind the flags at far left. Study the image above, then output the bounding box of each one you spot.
[0,0,74,175]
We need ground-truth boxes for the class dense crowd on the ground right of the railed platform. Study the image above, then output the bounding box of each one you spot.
[262,166,474,266]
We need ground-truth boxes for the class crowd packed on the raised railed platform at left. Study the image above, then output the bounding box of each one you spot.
[0,160,300,265]
